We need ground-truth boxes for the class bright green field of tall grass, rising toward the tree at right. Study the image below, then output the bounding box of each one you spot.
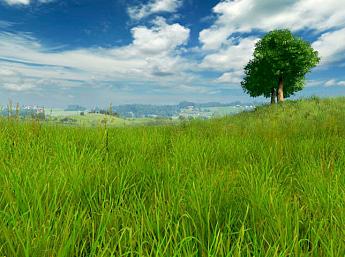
[0,98,345,257]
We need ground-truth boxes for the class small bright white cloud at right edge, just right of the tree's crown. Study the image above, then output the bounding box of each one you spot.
[312,28,345,64]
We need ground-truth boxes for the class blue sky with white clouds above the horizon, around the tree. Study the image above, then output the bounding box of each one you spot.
[0,0,345,107]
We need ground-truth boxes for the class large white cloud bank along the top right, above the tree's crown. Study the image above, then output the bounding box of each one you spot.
[199,0,345,49]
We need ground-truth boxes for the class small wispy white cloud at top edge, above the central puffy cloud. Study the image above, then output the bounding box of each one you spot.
[127,0,182,20]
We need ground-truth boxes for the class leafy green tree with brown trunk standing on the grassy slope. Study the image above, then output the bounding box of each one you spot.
[241,29,320,104]
